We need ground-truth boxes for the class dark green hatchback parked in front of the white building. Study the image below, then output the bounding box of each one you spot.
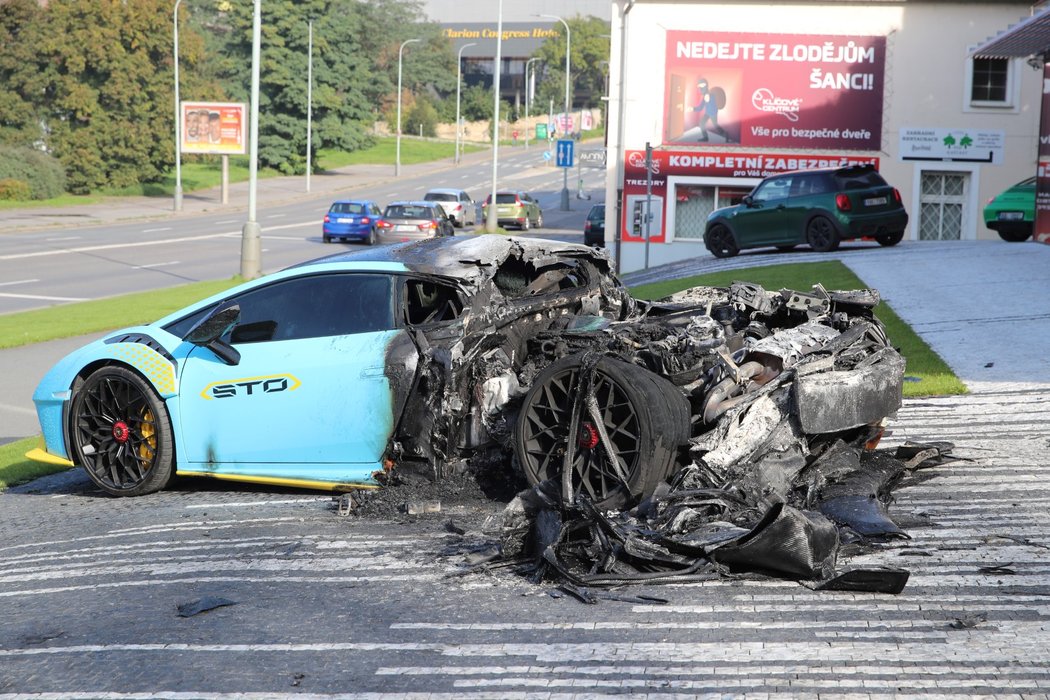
[704,165,908,257]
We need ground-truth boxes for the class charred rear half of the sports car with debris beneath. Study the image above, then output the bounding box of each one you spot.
[354,236,948,590]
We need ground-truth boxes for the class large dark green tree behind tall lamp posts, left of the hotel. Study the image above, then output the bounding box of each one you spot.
[217,0,455,173]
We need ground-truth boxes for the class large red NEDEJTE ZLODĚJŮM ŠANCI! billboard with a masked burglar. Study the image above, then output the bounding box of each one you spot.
[664,31,886,151]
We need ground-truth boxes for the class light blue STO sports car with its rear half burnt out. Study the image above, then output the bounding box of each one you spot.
[28,235,903,506]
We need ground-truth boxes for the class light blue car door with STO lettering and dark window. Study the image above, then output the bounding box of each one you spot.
[176,273,406,482]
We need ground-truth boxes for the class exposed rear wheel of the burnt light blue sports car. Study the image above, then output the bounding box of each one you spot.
[515,356,690,508]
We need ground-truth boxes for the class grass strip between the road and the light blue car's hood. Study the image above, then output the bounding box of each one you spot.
[0,277,243,349]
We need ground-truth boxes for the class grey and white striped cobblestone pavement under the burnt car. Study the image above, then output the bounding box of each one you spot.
[0,389,1050,700]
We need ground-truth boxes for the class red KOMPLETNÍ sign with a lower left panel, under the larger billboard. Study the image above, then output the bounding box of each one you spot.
[620,150,877,242]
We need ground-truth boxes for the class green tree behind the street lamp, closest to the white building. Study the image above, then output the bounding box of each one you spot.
[533,16,609,117]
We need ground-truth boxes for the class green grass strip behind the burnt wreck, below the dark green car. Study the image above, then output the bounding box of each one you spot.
[631,260,967,397]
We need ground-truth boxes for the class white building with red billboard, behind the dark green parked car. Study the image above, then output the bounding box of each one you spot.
[606,0,1043,272]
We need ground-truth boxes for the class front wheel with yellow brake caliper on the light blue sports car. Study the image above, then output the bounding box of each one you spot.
[69,365,174,495]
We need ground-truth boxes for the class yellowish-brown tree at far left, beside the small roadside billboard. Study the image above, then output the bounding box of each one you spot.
[0,0,213,192]
